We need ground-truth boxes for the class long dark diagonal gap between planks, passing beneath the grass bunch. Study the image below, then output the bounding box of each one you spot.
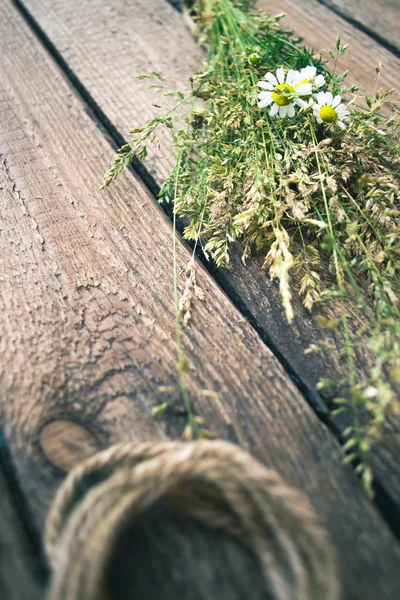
[12,0,400,541]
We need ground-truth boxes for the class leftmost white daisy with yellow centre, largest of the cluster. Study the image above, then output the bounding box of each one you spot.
[257,68,312,119]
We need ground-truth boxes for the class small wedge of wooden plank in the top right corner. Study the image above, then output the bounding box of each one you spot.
[321,0,400,52]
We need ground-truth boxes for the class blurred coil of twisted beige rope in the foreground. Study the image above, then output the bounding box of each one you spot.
[45,441,338,600]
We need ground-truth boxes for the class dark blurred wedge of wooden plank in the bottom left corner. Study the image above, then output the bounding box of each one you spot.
[0,454,42,600]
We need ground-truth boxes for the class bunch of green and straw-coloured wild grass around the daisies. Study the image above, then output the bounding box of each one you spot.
[104,0,400,487]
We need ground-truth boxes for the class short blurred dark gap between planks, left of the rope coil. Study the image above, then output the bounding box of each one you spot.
[0,428,49,588]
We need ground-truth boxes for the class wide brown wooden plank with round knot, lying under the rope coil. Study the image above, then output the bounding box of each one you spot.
[0,3,400,600]
